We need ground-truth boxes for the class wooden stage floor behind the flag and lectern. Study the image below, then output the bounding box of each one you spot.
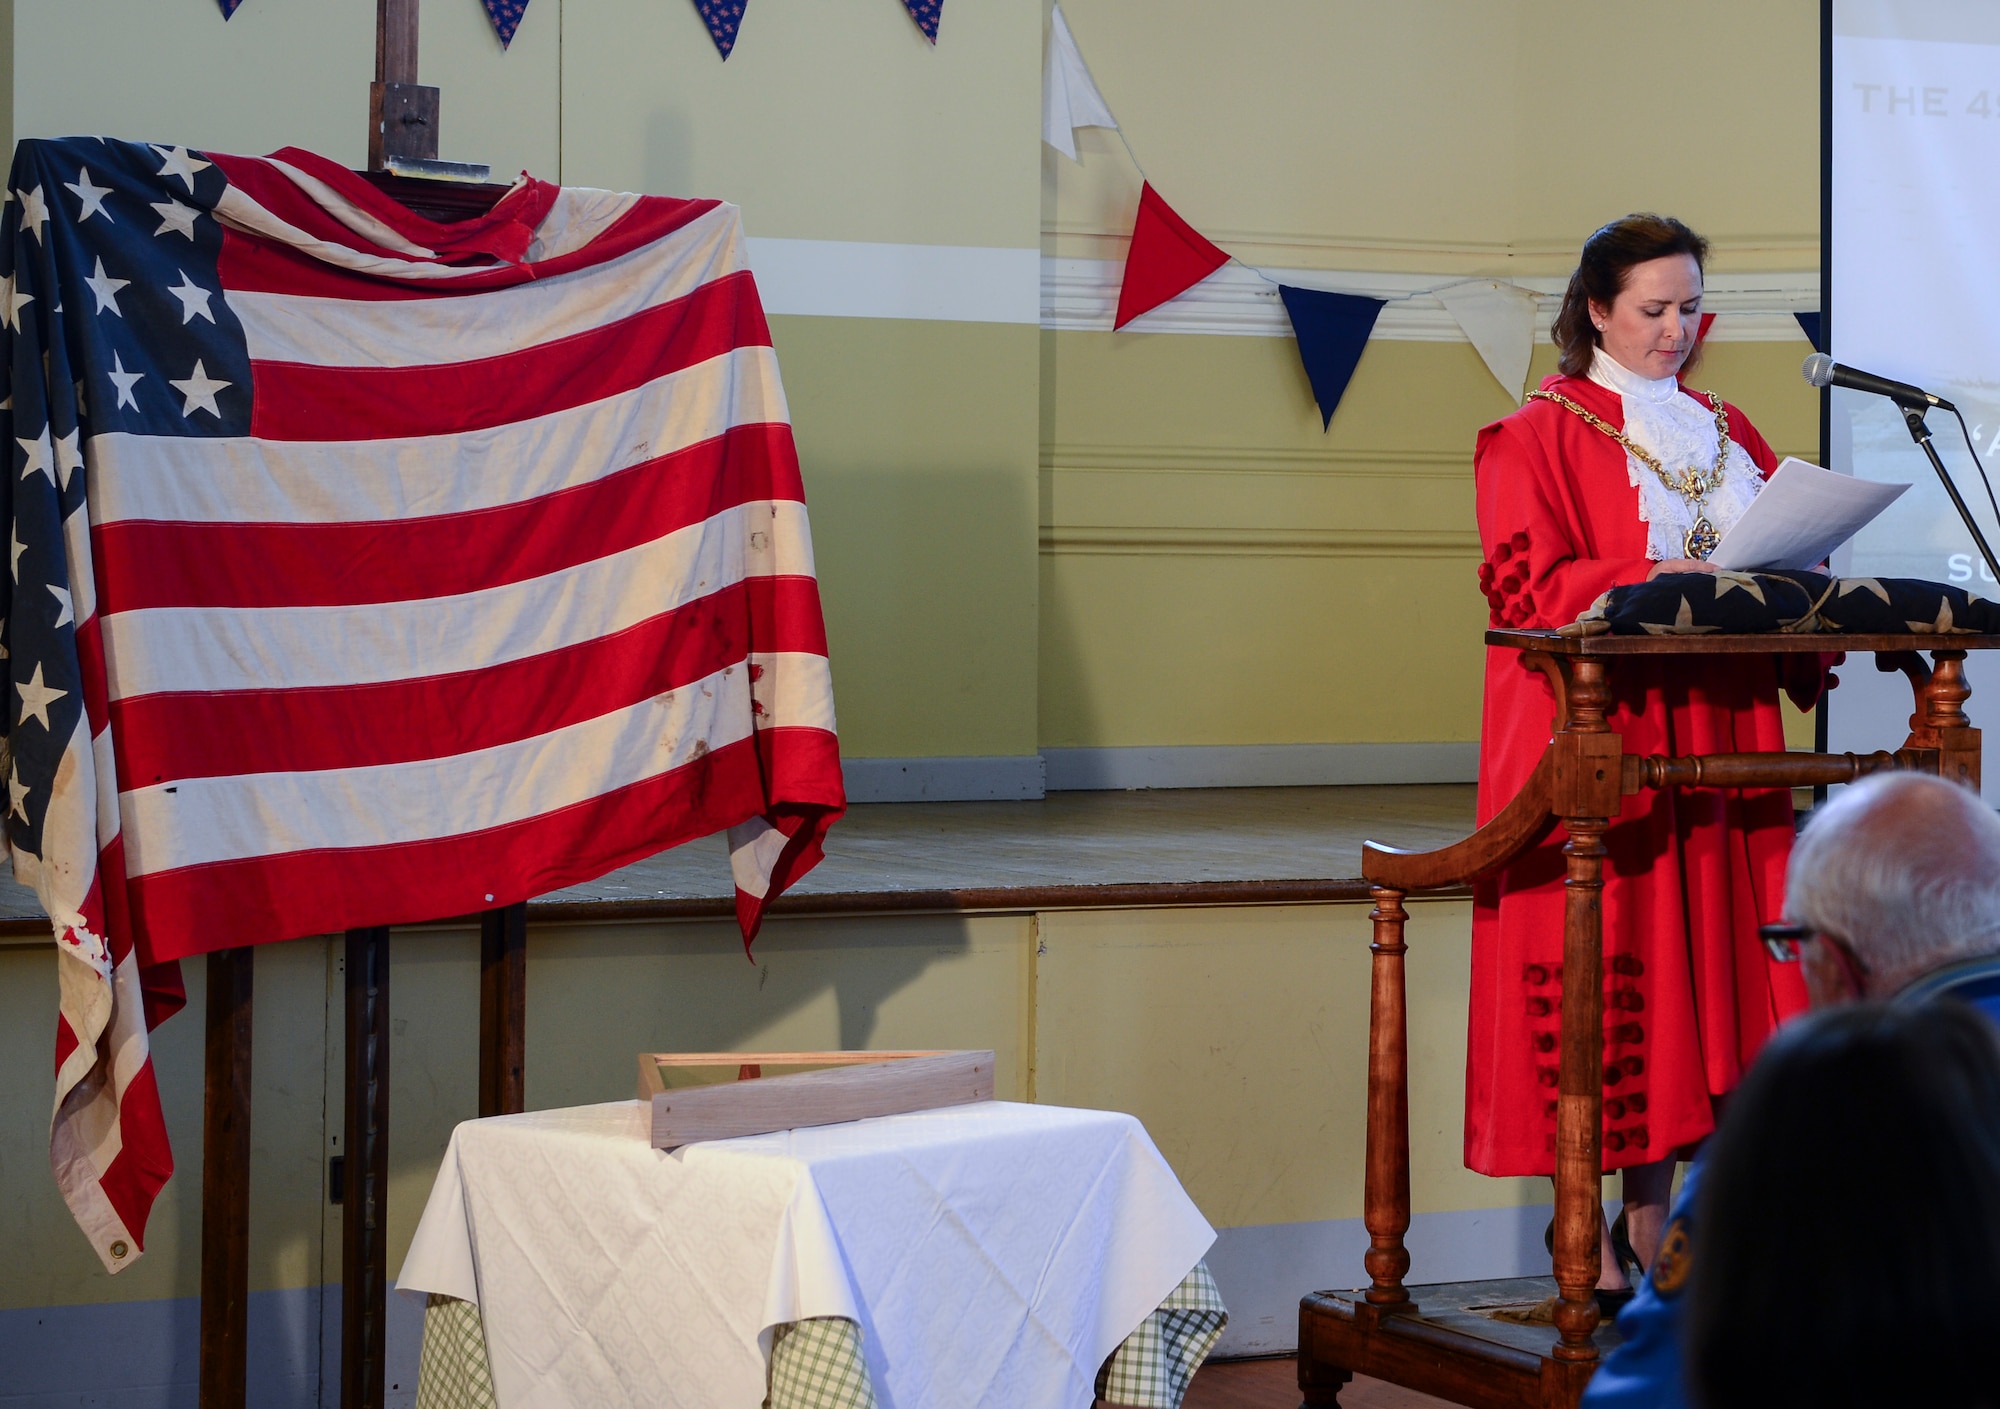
[0,783,1474,923]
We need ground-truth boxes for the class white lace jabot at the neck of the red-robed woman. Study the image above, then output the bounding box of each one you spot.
[1590,348,1764,562]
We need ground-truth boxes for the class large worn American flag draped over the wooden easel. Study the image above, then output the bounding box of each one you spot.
[0,138,844,1271]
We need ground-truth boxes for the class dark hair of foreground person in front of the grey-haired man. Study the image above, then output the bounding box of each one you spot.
[1682,1001,2000,1409]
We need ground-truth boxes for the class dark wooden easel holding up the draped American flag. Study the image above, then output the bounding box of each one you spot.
[198,0,528,1409]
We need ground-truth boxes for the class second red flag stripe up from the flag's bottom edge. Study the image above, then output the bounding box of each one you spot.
[112,576,826,789]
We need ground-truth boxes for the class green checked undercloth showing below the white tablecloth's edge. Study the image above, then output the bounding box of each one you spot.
[416,1263,1230,1409]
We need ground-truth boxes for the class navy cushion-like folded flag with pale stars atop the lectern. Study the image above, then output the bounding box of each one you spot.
[1562,572,2000,636]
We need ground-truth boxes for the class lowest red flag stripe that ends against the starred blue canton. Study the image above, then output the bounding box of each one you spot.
[250,272,770,440]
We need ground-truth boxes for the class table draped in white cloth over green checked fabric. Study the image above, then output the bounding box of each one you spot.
[398,1101,1224,1409]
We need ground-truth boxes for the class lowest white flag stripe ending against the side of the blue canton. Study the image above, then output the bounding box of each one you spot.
[224,206,744,366]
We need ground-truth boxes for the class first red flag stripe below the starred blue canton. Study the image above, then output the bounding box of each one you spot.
[94,422,806,614]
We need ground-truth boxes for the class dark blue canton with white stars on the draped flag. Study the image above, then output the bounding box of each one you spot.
[0,138,250,857]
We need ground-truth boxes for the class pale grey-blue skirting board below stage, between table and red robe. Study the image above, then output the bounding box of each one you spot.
[1208,1203,1616,1357]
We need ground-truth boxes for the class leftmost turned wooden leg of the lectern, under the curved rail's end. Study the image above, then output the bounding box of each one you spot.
[1368,885,1410,1312]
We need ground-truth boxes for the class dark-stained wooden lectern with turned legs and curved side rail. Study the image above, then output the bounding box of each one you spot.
[1298,630,2000,1409]
